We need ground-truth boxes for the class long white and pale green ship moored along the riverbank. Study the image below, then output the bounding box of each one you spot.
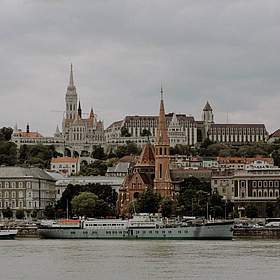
[39,214,233,240]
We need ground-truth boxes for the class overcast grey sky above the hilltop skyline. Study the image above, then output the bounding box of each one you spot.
[0,0,280,136]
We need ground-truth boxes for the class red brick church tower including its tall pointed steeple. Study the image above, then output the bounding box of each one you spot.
[154,88,174,198]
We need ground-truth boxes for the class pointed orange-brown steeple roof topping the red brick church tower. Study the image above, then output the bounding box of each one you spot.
[156,87,169,145]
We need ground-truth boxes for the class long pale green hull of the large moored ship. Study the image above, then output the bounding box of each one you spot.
[39,222,233,240]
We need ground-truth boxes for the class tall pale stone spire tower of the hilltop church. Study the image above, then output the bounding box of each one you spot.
[65,64,78,120]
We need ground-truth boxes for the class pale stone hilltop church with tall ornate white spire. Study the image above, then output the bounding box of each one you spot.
[60,64,104,151]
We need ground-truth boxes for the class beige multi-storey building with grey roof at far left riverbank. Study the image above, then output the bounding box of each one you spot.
[0,167,55,218]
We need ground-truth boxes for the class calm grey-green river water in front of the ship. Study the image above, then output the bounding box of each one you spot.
[0,239,280,280]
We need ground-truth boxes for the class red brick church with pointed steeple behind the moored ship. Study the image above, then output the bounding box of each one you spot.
[118,89,174,215]
